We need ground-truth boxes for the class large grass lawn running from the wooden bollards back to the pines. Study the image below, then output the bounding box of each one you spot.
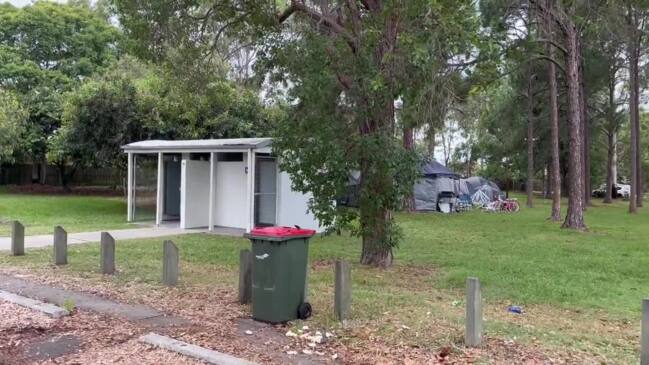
[0,196,649,363]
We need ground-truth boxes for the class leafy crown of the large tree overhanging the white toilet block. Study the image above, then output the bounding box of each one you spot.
[109,0,478,262]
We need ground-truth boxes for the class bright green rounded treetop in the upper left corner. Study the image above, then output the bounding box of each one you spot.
[0,1,120,86]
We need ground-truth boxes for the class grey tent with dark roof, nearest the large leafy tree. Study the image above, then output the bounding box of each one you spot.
[414,160,460,211]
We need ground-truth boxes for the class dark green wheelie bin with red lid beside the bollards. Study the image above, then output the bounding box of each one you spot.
[246,227,315,323]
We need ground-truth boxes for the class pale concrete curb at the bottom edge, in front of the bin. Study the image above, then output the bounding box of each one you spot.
[138,332,257,365]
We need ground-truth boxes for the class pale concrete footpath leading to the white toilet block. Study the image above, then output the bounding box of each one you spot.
[0,226,207,251]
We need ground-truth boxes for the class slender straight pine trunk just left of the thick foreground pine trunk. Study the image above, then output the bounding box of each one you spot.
[544,1,561,222]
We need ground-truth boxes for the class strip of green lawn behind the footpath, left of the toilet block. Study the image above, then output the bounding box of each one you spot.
[0,190,129,237]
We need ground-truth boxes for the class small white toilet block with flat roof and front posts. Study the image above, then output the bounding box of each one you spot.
[122,138,319,232]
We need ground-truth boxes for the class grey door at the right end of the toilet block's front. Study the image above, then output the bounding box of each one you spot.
[254,154,277,227]
